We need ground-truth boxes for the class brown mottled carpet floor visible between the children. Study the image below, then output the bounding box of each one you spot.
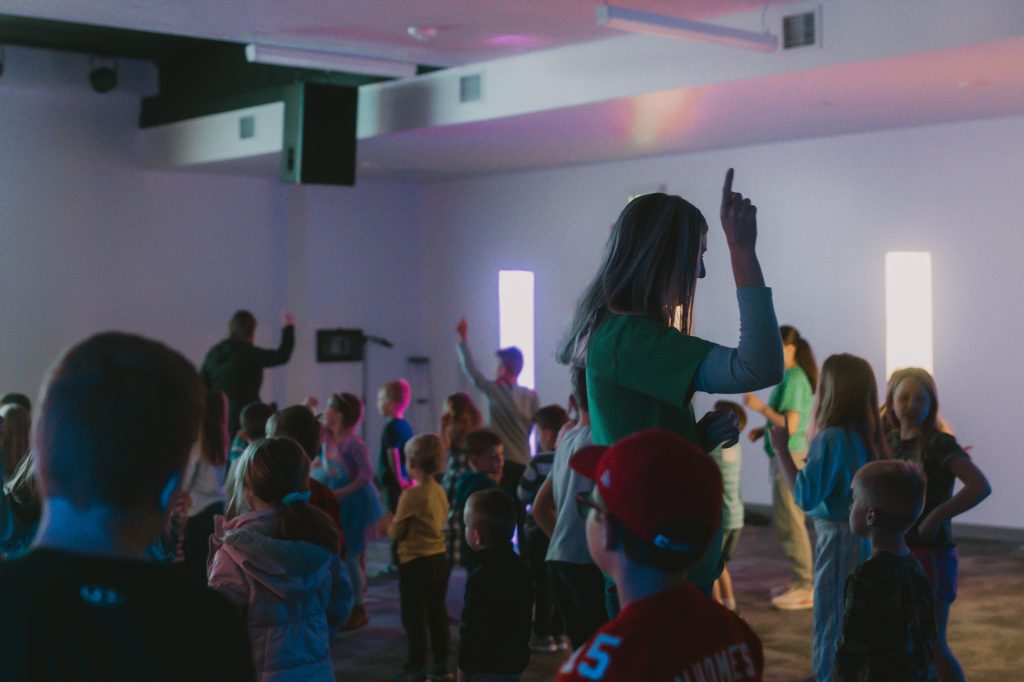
[331,524,1024,682]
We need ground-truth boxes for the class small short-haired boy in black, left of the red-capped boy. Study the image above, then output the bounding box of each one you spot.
[459,488,534,682]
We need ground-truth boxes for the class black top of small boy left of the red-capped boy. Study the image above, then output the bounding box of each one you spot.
[459,543,534,675]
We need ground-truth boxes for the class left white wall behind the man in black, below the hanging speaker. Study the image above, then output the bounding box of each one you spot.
[0,48,420,446]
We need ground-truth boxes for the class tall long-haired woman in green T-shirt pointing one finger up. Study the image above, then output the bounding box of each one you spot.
[557,168,782,595]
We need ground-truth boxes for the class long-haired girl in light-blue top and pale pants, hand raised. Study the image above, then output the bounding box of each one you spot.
[771,353,889,682]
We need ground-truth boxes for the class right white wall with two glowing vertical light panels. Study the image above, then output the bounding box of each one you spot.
[413,118,1024,527]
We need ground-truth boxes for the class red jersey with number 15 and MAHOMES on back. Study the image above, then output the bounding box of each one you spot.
[557,583,764,682]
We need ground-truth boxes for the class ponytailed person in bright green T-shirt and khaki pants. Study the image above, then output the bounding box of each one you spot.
[744,325,818,610]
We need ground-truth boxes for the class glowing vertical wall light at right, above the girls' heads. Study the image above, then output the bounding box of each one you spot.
[886,251,934,378]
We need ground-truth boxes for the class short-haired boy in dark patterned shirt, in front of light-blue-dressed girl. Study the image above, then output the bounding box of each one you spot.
[834,460,936,682]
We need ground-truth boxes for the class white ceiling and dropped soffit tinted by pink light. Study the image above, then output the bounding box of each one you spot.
[0,0,1024,179]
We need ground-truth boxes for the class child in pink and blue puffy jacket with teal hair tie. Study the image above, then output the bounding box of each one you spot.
[209,437,352,682]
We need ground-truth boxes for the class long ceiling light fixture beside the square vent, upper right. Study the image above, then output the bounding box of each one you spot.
[597,5,778,52]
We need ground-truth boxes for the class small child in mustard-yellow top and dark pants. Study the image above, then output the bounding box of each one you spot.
[388,433,455,682]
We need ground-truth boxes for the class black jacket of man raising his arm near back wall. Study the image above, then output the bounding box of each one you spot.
[203,325,295,436]
